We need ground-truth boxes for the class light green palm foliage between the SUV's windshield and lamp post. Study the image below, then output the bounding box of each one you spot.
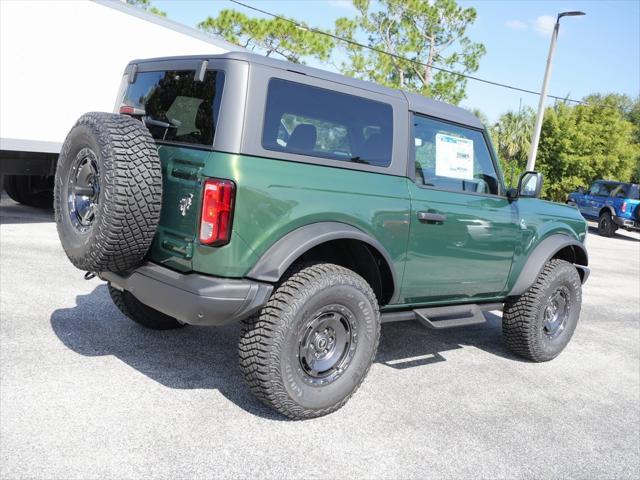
[491,107,535,186]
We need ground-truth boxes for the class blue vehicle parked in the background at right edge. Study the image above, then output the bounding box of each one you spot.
[567,180,640,237]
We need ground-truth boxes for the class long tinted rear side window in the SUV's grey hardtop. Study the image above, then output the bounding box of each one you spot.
[262,78,393,167]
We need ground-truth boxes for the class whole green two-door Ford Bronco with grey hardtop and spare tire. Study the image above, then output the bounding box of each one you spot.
[55,52,589,418]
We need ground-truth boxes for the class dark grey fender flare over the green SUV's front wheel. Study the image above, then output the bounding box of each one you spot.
[508,234,589,297]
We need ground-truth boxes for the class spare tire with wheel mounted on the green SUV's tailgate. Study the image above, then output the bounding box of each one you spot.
[54,112,162,272]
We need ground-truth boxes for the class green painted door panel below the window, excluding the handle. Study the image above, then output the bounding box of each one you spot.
[402,181,519,304]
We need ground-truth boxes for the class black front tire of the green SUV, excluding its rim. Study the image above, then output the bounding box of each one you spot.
[502,259,582,362]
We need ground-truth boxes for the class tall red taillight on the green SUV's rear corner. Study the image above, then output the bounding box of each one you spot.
[200,180,235,246]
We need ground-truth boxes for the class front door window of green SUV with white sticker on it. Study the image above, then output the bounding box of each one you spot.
[413,114,501,195]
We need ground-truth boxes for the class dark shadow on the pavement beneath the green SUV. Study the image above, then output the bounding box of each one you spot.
[50,285,514,420]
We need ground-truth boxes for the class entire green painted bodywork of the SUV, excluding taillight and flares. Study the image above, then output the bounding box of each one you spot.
[149,145,586,309]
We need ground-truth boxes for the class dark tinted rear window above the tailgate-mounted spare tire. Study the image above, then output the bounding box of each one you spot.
[123,70,224,146]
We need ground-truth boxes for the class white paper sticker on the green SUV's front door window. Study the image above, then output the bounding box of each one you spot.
[436,133,473,180]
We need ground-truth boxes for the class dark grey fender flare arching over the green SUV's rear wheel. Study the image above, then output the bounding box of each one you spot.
[246,222,398,298]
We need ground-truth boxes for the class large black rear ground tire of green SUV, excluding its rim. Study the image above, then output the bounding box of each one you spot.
[239,263,380,419]
